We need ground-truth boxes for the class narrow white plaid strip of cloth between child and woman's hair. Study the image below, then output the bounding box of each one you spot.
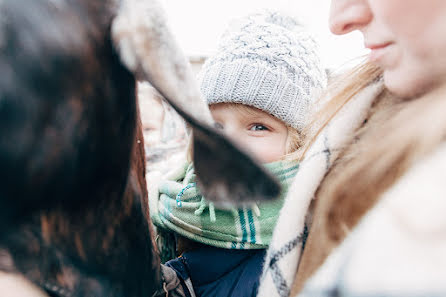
[258,81,383,297]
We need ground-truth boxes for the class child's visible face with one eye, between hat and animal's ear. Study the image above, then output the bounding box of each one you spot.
[210,103,288,163]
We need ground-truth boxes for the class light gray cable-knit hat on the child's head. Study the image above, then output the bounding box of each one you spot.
[198,11,327,130]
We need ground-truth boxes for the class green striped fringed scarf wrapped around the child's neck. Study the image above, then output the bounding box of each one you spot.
[149,161,299,249]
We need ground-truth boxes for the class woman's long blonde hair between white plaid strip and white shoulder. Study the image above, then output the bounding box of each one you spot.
[291,77,446,295]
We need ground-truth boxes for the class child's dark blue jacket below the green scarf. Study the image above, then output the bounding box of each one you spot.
[166,247,266,297]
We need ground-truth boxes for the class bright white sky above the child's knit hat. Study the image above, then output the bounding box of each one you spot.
[161,0,367,69]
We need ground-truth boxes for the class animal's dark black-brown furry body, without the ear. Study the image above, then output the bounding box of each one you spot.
[0,0,169,297]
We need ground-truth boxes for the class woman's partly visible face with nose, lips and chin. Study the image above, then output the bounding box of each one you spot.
[330,0,446,96]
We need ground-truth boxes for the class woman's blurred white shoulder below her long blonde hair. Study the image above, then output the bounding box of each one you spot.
[302,143,446,296]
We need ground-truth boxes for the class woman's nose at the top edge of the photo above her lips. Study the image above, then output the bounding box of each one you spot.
[329,0,373,35]
